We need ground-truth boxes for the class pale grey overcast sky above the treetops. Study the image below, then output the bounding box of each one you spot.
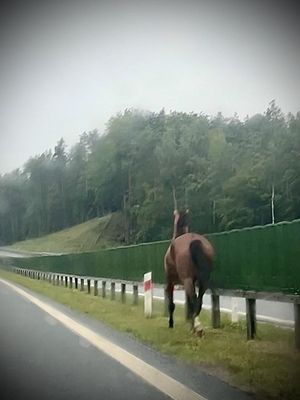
[0,0,300,174]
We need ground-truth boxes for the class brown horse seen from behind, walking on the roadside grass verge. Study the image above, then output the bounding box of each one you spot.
[164,210,214,336]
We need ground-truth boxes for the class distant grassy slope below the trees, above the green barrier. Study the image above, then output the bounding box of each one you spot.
[10,214,122,253]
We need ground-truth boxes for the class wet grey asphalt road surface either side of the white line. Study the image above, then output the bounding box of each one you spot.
[0,280,251,400]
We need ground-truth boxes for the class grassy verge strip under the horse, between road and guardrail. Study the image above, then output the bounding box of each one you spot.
[0,270,300,400]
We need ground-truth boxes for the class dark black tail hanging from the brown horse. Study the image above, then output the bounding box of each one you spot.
[190,239,211,290]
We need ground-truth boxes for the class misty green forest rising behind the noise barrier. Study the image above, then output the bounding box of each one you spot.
[0,100,300,245]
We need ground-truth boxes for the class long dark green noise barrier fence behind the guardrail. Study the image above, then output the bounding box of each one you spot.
[5,220,300,295]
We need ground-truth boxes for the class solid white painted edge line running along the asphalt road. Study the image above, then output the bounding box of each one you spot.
[0,279,207,400]
